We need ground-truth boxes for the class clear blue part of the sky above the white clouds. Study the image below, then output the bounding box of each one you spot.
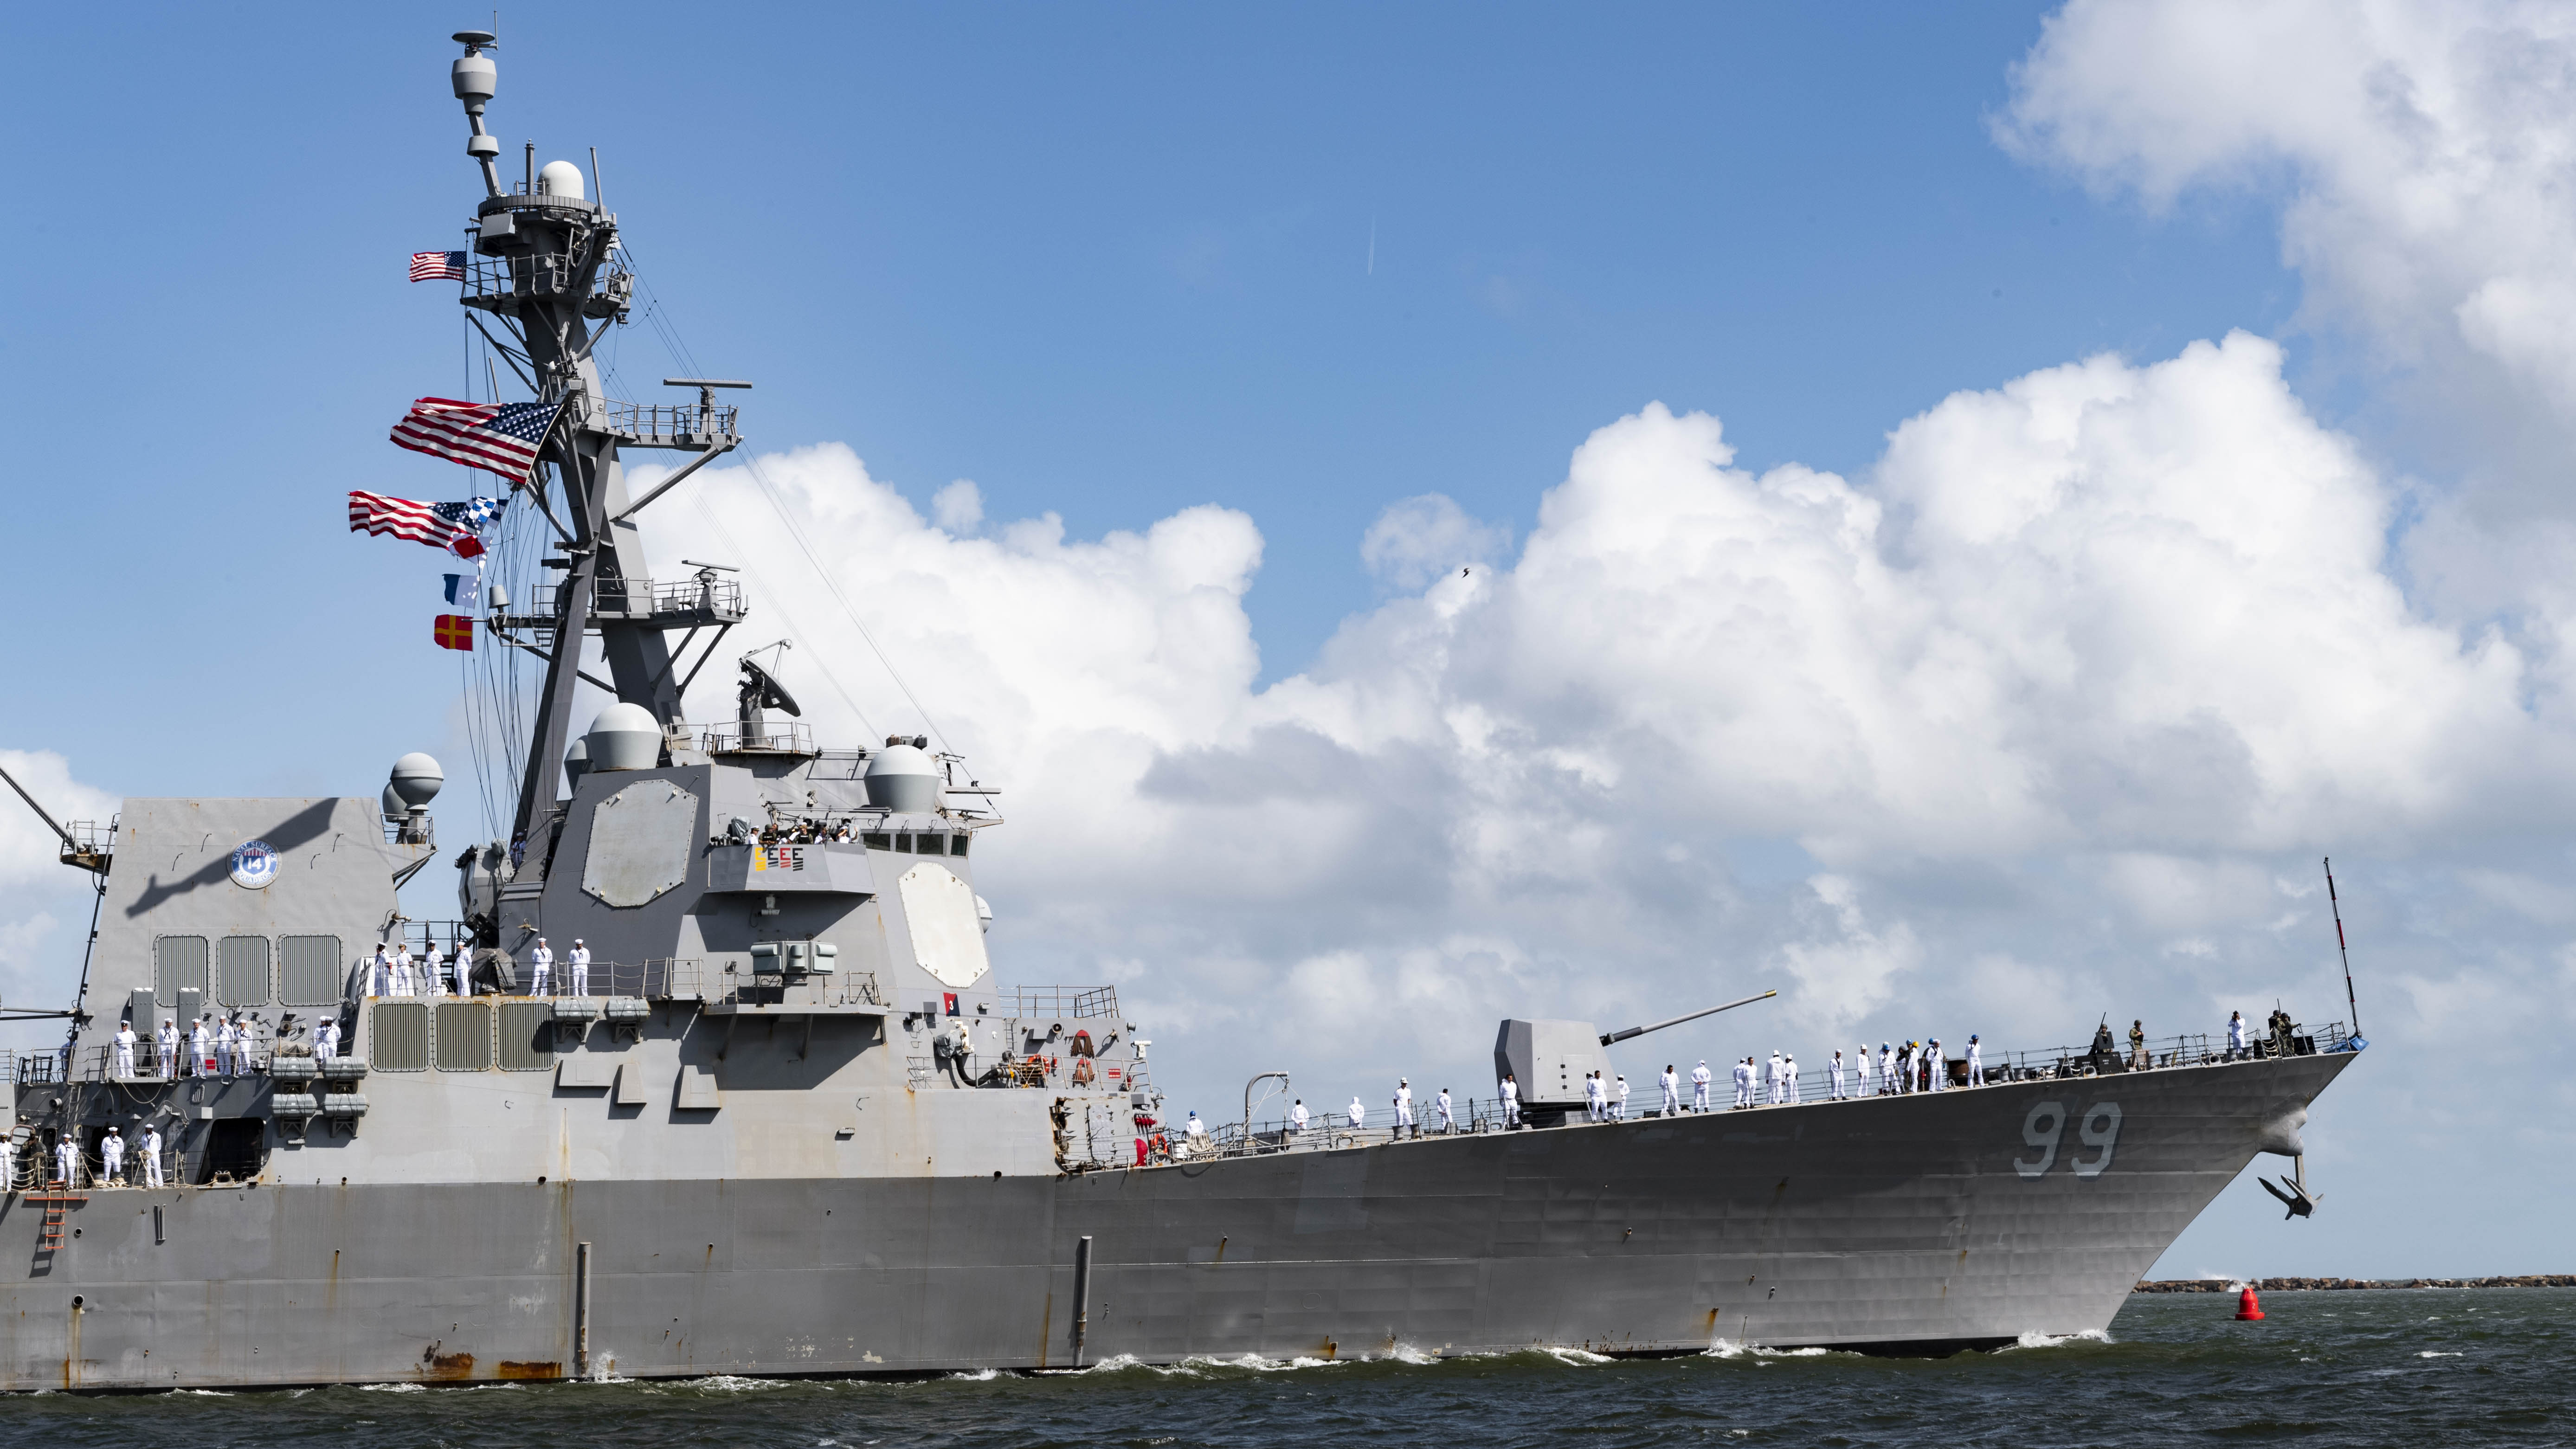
[0,5,2298,792]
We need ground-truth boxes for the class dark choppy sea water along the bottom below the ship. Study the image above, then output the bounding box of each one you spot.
[0,1289,2576,1449]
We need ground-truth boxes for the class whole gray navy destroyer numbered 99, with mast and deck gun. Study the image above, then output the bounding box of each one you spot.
[0,31,2360,1390]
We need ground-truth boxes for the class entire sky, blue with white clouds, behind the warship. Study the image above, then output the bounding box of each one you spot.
[15,0,2576,1274]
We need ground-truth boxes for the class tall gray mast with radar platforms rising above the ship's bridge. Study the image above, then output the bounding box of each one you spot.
[451,31,750,858]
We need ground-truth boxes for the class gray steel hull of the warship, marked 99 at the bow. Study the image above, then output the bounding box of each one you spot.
[0,1052,2352,1390]
